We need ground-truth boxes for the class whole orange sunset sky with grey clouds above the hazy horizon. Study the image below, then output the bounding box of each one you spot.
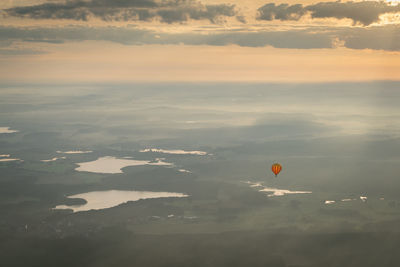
[0,0,400,83]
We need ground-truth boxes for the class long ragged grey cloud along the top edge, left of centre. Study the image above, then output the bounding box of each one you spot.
[3,0,240,23]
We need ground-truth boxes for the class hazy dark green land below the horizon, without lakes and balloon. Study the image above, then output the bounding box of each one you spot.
[0,82,400,267]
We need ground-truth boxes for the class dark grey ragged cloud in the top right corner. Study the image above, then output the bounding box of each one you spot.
[258,1,400,25]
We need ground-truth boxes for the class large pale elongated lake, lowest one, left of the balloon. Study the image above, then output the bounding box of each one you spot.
[54,190,188,212]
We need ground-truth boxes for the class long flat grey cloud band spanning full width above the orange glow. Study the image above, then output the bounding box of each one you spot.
[0,25,400,51]
